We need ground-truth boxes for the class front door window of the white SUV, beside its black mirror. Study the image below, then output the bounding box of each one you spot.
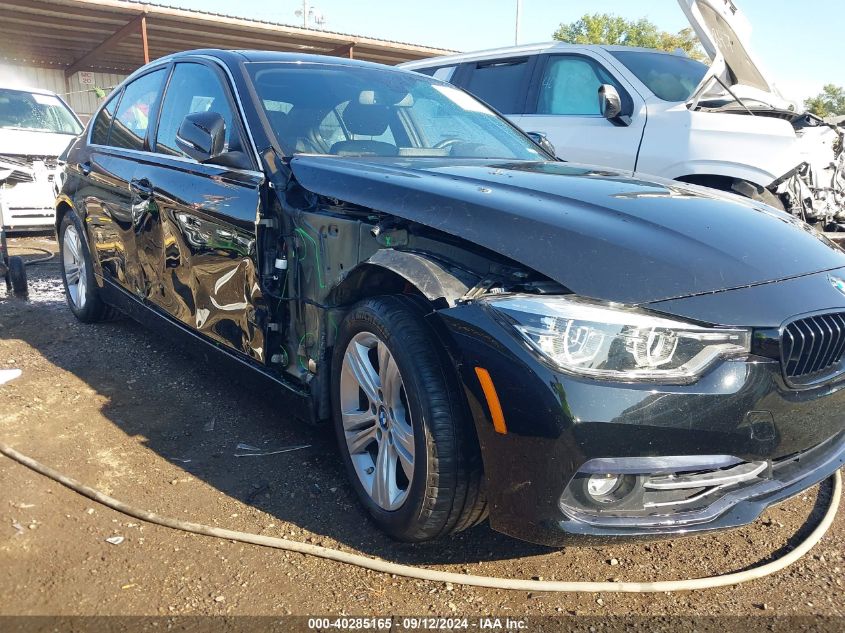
[537,55,625,116]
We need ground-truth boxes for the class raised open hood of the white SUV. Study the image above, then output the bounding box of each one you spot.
[678,0,784,107]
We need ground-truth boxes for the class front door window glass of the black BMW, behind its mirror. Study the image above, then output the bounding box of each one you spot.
[156,63,242,156]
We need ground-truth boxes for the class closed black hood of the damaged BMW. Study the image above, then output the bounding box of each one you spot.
[291,155,845,304]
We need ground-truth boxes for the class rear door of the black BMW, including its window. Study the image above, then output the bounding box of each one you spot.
[79,66,167,296]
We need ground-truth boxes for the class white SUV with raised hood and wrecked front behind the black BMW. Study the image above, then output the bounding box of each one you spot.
[403,0,845,231]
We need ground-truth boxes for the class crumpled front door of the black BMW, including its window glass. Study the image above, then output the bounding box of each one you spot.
[135,61,265,362]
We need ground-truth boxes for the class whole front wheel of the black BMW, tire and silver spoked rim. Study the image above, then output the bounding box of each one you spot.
[332,296,487,542]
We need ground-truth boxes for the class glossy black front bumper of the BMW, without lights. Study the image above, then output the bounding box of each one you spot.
[437,304,845,545]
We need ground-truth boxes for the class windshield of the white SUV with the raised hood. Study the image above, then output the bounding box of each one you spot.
[611,51,707,101]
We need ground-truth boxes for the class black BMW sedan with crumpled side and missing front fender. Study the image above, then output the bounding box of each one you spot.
[56,50,845,544]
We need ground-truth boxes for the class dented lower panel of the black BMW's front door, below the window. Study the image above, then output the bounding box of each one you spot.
[134,155,265,363]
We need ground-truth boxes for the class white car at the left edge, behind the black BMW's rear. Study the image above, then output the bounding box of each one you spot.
[0,85,83,231]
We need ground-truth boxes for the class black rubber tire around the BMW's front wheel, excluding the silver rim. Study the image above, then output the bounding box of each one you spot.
[332,296,487,542]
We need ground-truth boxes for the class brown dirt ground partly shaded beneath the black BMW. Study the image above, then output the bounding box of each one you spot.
[0,236,845,630]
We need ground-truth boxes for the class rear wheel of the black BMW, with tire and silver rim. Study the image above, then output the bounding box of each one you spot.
[59,210,120,323]
